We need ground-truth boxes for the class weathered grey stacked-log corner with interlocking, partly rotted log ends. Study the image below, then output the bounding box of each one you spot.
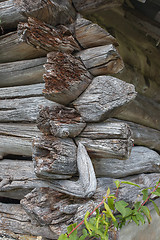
[0,0,160,239]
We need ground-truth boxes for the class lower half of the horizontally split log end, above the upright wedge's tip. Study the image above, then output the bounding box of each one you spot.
[76,136,133,161]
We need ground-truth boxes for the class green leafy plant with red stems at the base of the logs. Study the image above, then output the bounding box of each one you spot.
[58,180,160,240]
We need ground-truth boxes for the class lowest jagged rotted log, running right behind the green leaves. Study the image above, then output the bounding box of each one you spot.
[21,174,160,235]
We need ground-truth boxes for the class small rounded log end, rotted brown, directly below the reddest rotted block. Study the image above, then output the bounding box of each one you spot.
[37,105,86,138]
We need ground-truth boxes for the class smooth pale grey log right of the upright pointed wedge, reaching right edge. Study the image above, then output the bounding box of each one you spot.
[92,147,160,178]
